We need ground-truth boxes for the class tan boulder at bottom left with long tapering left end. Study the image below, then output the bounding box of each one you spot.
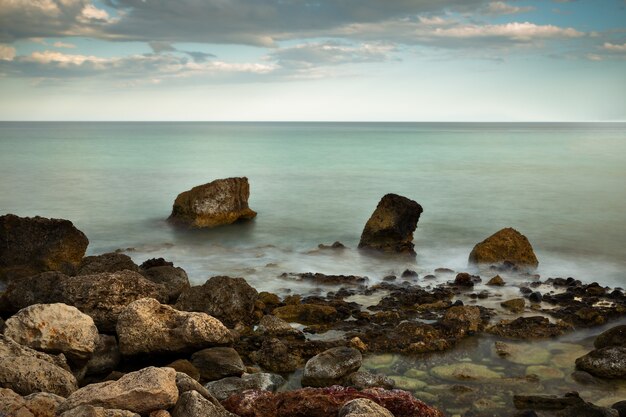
[57,367,178,414]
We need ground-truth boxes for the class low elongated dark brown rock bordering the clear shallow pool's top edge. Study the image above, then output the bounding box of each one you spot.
[486,316,571,339]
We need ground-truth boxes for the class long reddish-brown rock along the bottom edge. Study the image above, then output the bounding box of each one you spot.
[223,386,443,417]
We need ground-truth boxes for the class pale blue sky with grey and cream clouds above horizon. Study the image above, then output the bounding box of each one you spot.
[0,0,626,122]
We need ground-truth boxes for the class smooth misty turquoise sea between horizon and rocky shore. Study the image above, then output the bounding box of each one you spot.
[0,123,626,291]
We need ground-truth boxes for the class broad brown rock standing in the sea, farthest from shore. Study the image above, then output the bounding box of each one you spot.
[170,177,256,228]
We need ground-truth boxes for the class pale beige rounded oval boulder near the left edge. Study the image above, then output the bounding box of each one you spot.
[4,304,98,360]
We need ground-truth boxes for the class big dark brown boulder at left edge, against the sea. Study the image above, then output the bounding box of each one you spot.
[0,214,89,279]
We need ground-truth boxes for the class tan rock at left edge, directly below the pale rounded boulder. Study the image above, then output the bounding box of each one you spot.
[0,335,77,397]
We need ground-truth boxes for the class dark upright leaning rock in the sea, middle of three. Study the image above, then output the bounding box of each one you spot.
[359,194,423,255]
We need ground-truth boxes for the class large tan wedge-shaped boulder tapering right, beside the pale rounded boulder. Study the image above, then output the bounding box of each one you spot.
[117,298,233,356]
